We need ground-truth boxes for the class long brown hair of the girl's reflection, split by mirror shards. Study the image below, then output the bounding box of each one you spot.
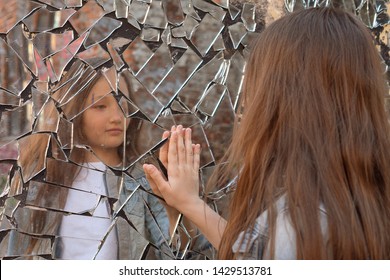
[19,64,139,253]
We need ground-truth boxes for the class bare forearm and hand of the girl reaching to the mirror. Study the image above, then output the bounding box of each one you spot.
[144,126,226,249]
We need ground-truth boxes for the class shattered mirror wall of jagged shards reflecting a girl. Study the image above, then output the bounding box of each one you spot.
[0,0,390,259]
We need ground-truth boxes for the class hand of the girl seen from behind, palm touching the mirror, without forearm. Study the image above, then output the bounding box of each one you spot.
[144,126,200,212]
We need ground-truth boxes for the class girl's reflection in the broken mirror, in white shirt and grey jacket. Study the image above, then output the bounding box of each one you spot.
[1,63,177,259]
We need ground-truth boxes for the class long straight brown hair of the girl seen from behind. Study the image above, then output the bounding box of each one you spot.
[215,8,390,259]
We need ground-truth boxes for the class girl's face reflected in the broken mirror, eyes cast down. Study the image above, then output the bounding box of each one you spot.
[82,79,129,162]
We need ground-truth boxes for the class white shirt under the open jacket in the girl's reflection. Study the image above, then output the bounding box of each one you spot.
[59,162,118,260]
